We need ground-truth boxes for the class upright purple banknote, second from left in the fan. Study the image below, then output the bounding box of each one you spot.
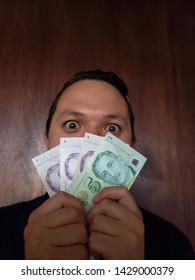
[60,137,84,193]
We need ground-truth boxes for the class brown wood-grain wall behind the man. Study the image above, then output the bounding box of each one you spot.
[0,0,195,247]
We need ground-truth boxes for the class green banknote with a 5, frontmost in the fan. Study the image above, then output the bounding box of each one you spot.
[70,133,146,211]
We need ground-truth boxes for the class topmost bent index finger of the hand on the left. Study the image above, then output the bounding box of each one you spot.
[30,192,85,221]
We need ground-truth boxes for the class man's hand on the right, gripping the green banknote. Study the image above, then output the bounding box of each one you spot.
[87,186,144,260]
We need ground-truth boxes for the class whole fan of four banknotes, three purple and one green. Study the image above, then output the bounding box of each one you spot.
[32,132,146,211]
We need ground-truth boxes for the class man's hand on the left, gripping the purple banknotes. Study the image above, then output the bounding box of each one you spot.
[24,192,89,260]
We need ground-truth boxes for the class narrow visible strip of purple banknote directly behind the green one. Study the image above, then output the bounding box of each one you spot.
[71,132,103,184]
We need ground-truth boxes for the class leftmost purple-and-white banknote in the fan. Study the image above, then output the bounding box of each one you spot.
[32,145,60,196]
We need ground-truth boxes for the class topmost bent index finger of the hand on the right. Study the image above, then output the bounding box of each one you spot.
[93,186,142,219]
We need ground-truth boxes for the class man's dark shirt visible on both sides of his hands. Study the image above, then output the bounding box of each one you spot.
[0,194,194,260]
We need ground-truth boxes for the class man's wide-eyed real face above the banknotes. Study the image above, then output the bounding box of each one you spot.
[45,80,132,149]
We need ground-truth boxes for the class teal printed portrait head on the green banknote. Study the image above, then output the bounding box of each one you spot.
[95,154,132,186]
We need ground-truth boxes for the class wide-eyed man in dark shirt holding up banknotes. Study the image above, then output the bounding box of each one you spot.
[0,70,193,259]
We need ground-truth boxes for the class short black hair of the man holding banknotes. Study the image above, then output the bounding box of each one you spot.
[46,69,136,142]
